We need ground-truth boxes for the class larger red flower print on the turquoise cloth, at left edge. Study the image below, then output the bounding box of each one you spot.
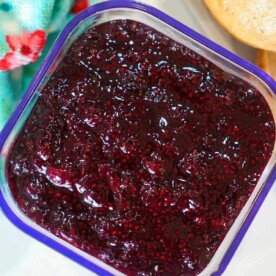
[0,30,46,70]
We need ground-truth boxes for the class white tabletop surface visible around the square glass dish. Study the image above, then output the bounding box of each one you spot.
[0,0,276,276]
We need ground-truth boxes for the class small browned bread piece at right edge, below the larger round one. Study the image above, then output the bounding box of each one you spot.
[256,50,276,80]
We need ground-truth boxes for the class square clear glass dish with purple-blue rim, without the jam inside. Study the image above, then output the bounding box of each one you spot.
[0,1,276,275]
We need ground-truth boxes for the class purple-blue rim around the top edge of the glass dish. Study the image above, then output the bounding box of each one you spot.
[0,0,276,276]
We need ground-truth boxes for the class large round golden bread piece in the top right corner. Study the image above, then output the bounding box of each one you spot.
[204,0,276,52]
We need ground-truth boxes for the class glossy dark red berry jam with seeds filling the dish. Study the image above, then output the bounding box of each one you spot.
[8,20,275,275]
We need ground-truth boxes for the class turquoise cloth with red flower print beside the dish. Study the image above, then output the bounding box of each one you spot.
[0,0,99,130]
